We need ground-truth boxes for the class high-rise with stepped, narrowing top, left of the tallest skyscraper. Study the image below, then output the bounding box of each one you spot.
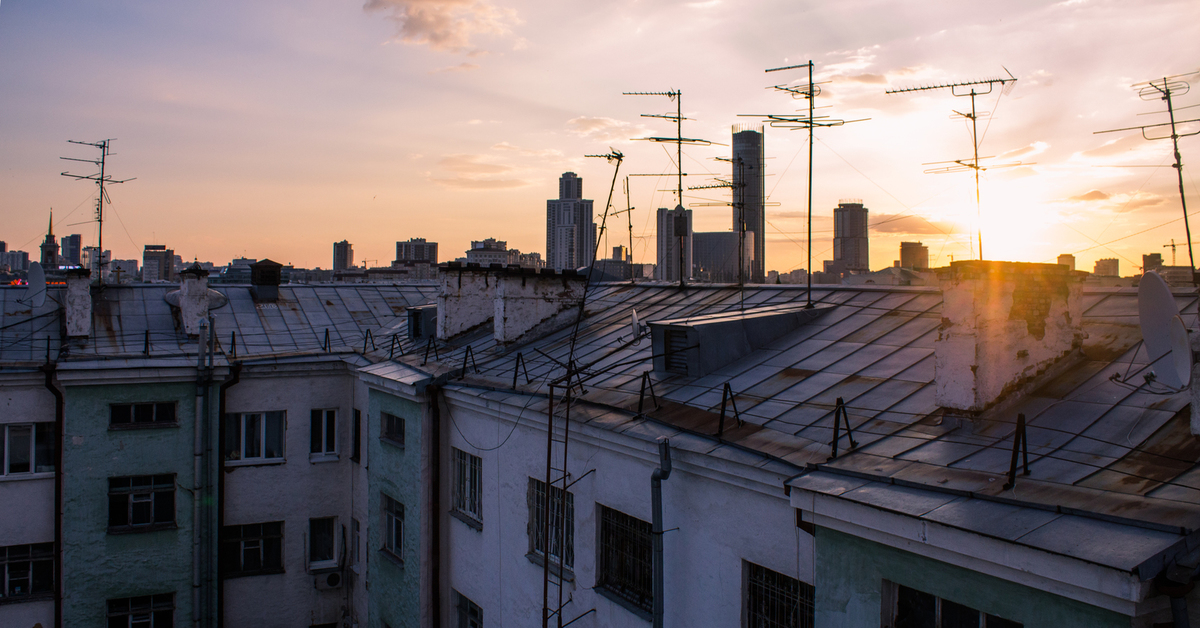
[546,172,596,270]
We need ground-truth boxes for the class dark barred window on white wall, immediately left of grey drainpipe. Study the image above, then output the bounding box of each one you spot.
[596,504,654,611]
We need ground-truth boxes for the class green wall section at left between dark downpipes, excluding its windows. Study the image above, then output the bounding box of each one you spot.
[62,383,206,626]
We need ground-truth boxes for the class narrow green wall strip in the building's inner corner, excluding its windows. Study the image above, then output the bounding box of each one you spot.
[365,389,425,628]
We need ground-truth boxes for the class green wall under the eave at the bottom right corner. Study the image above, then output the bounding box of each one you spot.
[816,528,1129,628]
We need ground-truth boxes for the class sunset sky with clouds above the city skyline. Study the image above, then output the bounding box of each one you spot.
[0,0,1200,275]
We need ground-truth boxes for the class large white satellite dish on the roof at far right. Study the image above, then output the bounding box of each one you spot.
[1138,270,1192,388]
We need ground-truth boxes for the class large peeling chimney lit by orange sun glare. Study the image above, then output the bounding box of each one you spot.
[934,261,1084,413]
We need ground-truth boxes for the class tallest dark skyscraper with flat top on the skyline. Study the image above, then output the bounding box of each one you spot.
[733,125,767,283]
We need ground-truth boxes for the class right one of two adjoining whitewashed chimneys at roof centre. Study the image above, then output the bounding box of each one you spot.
[493,265,587,345]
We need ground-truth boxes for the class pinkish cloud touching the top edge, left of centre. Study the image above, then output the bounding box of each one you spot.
[362,0,521,52]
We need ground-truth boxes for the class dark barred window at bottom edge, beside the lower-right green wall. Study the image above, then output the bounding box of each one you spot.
[742,562,814,628]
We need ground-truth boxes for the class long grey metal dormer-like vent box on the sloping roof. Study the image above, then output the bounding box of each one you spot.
[649,305,830,377]
